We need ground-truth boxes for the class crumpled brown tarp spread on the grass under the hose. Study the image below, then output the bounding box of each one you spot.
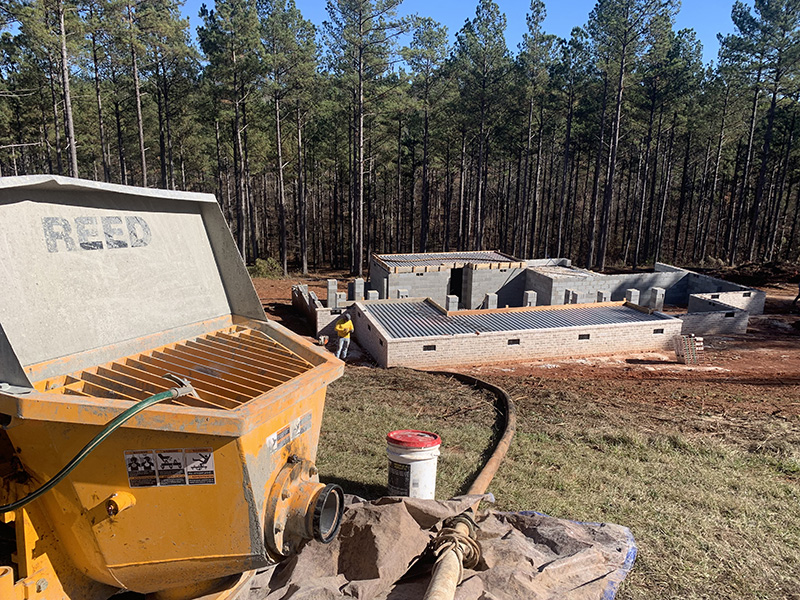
[237,496,636,600]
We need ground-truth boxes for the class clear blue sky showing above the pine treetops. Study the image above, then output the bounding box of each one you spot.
[183,0,733,63]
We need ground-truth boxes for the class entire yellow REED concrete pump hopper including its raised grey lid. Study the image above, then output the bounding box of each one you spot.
[0,176,343,600]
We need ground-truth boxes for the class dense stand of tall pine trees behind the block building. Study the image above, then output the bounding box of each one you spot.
[0,0,800,274]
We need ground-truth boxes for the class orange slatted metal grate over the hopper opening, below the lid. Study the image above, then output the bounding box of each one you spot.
[35,326,313,410]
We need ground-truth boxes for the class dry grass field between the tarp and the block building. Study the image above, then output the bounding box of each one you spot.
[318,367,800,600]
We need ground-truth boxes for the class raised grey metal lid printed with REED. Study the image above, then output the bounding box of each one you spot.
[0,175,266,385]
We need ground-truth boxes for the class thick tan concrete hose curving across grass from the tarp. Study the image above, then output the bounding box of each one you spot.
[423,371,517,600]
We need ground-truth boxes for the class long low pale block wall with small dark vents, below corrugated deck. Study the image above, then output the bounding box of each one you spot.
[372,315,682,368]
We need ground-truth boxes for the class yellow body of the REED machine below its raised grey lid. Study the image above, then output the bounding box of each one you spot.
[0,176,342,600]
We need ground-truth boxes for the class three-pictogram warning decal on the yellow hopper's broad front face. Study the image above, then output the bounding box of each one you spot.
[125,448,217,488]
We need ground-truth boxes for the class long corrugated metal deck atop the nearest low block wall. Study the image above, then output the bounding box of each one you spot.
[364,301,671,338]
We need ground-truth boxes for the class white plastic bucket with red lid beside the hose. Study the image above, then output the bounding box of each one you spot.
[386,429,442,500]
